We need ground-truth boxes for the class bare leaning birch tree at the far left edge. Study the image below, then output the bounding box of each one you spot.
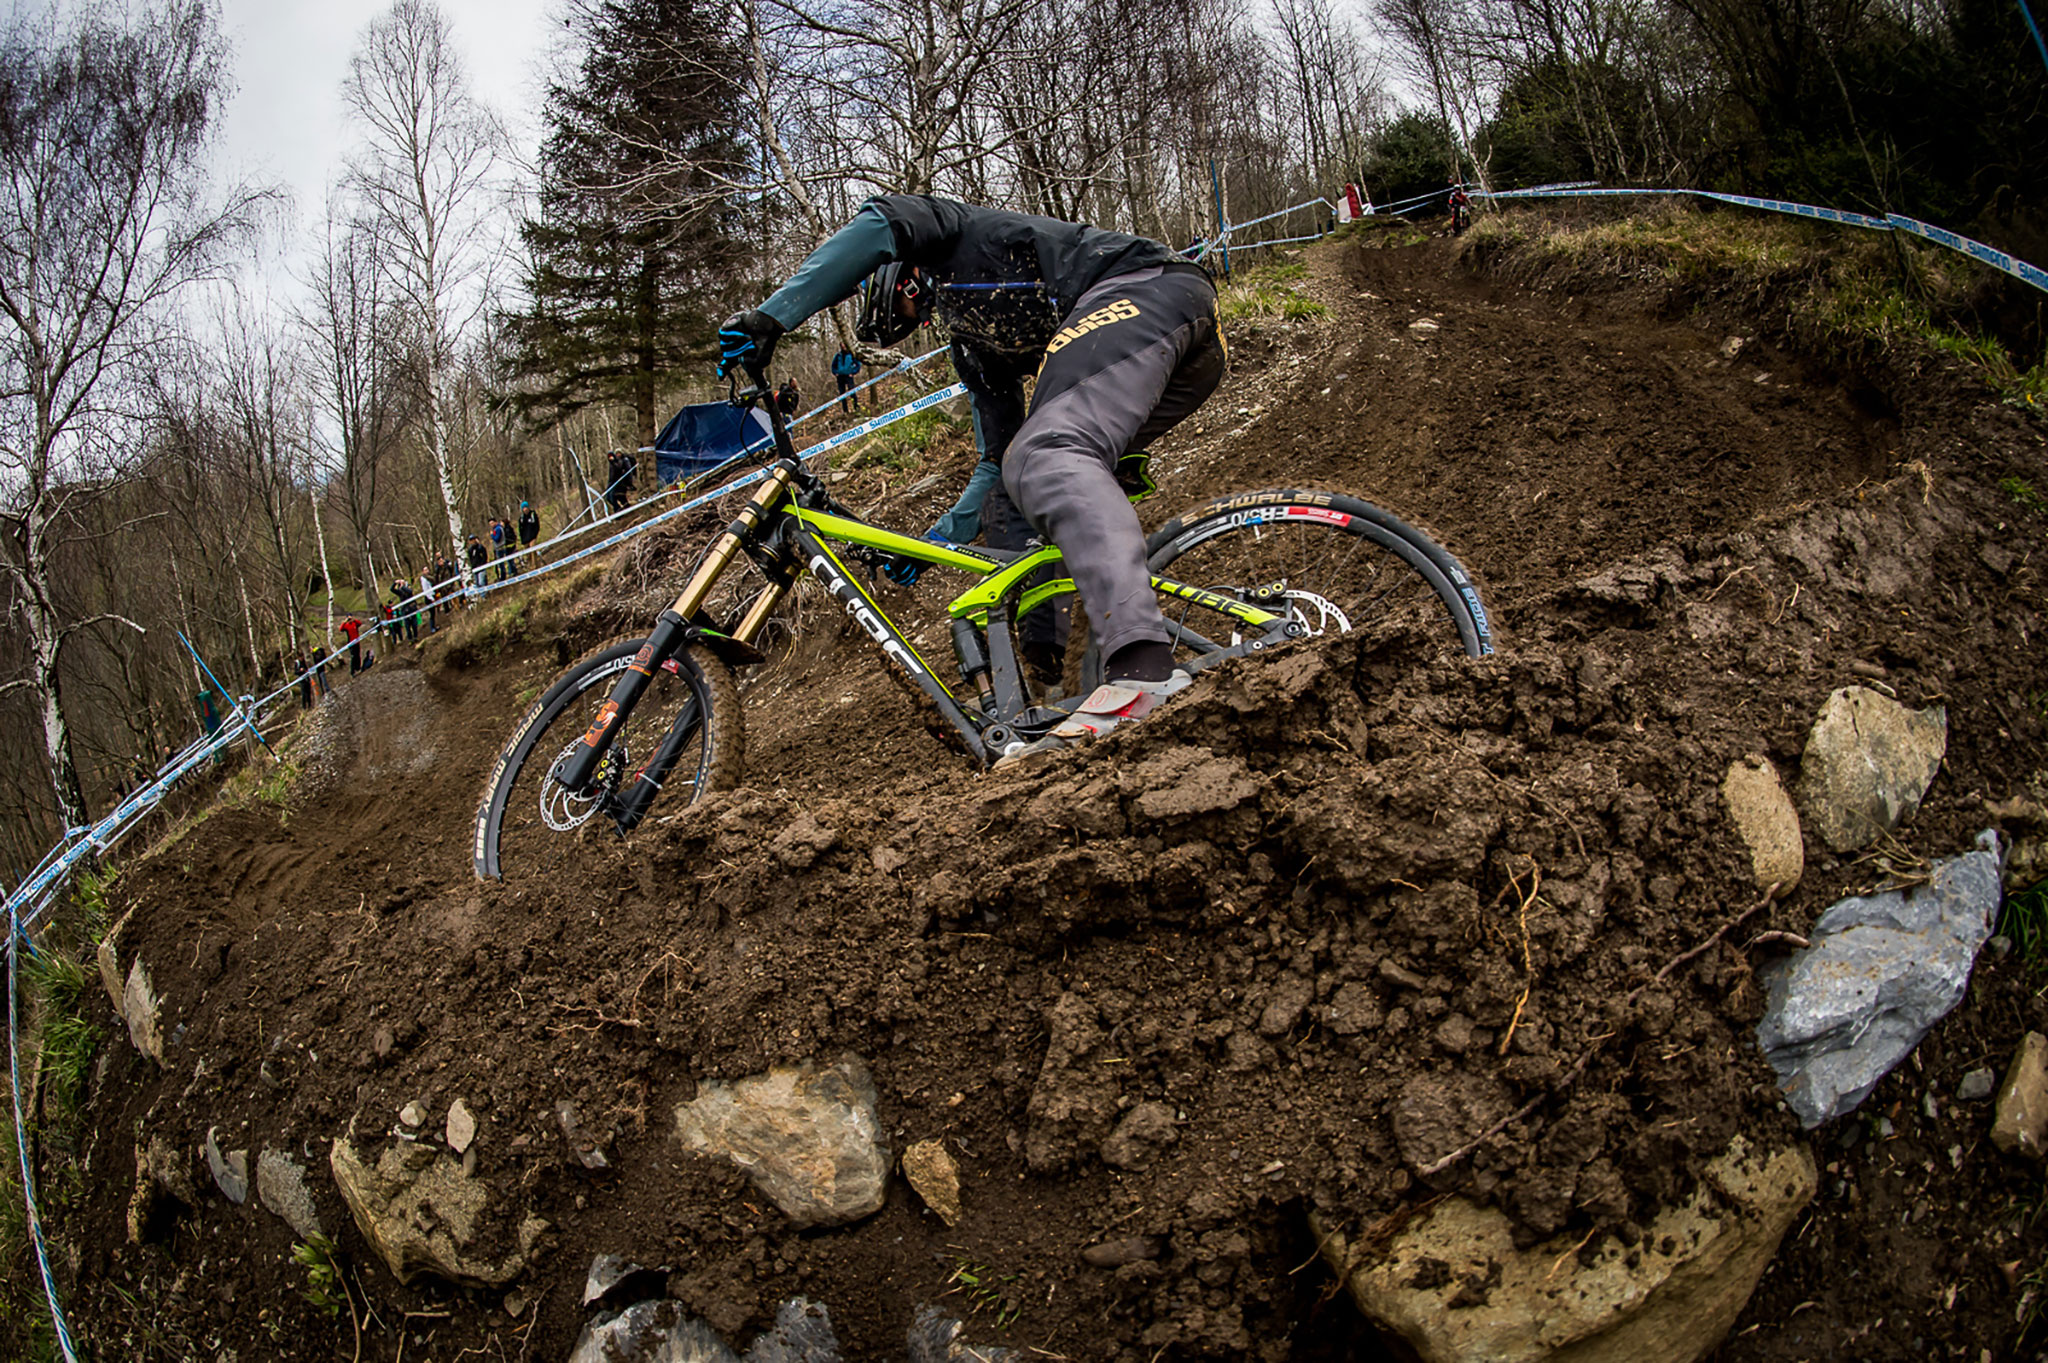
[0,0,258,825]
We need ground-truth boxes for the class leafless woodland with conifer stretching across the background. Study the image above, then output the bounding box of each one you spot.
[0,0,2048,871]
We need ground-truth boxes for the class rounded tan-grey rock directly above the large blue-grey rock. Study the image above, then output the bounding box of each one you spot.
[1800,686,1948,851]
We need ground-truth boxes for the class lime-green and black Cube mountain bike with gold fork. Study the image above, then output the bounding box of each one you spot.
[473,356,1493,880]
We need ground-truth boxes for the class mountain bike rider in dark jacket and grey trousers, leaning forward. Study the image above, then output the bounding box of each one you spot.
[719,194,1229,749]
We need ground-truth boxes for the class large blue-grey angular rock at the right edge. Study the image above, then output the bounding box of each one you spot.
[1757,833,1999,1128]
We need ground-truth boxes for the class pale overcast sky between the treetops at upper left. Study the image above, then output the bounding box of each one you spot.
[215,0,553,241]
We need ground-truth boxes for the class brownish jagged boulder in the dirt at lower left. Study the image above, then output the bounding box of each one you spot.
[328,1138,547,1287]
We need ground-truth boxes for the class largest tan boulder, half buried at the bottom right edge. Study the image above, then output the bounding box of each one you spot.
[1315,1138,1815,1363]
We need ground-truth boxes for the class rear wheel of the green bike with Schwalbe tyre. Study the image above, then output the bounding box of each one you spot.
[1083,489,1493,686]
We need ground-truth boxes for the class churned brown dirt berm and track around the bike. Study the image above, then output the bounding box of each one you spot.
[57,217,2048,1361]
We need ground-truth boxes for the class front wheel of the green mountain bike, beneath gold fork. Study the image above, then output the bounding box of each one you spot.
[473,636,743,880]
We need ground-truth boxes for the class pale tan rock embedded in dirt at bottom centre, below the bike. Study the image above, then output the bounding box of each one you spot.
[676,1043,889,1226]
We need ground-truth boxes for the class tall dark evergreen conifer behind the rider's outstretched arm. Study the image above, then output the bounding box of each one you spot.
[512,0,745,444]
